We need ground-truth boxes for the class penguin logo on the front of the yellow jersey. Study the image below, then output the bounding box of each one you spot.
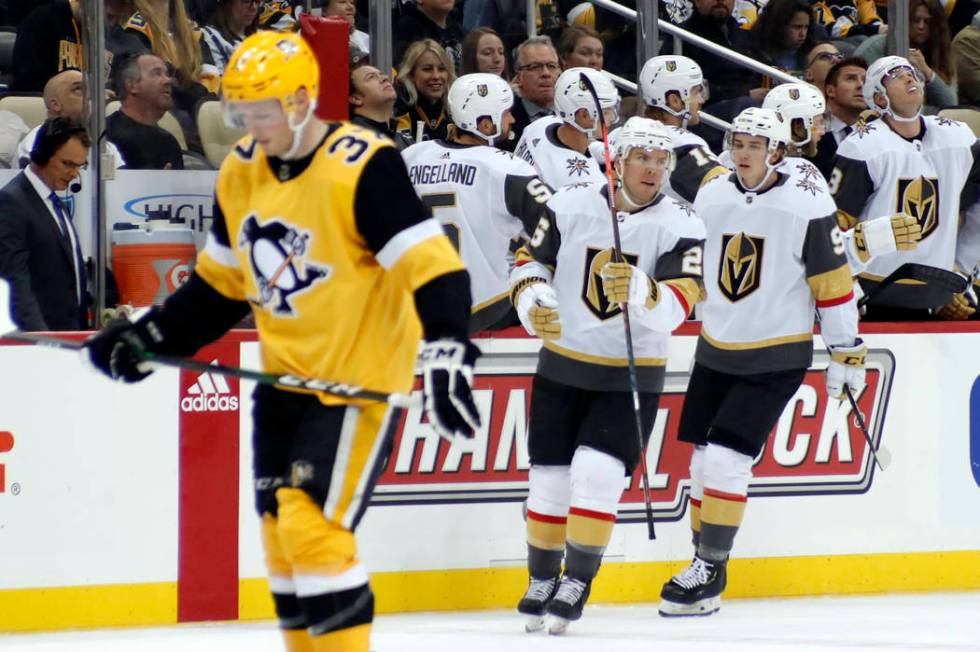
[238,214,332,317]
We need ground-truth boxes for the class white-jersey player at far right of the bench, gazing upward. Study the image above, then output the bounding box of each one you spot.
[828,56,980,319]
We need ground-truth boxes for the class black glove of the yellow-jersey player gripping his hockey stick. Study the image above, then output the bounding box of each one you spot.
[85,310,163,383]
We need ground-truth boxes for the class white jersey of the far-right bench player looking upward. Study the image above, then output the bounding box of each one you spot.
[829,116,980,282]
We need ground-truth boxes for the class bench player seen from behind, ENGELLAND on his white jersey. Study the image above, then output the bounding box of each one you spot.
[402,73,551,332]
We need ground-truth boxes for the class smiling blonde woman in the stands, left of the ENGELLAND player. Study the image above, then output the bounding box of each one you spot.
[395,39,456,142]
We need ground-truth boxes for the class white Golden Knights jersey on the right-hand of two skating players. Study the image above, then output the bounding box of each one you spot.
[694,168,858,375]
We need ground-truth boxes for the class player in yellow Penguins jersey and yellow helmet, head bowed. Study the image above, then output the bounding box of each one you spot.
[87,32,479,652]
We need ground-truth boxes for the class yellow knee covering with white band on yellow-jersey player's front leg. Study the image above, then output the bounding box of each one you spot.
[276,487,368,597]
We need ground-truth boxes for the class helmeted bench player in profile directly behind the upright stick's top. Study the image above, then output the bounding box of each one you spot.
[514,68,619,188]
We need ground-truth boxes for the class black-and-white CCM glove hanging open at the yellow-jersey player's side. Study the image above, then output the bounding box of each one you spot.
[419,339,481,441]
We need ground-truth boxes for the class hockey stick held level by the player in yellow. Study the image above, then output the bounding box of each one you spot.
[0,278,422,408]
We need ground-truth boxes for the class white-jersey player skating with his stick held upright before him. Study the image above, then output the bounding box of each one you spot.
[511,118,704,634]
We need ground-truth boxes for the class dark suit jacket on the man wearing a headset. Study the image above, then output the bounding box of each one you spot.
[0,171,86,331]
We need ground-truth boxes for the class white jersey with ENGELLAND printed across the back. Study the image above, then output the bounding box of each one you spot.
[402,140,551,331]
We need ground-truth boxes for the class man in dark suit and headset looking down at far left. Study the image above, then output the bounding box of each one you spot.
[0,118,91,331]
